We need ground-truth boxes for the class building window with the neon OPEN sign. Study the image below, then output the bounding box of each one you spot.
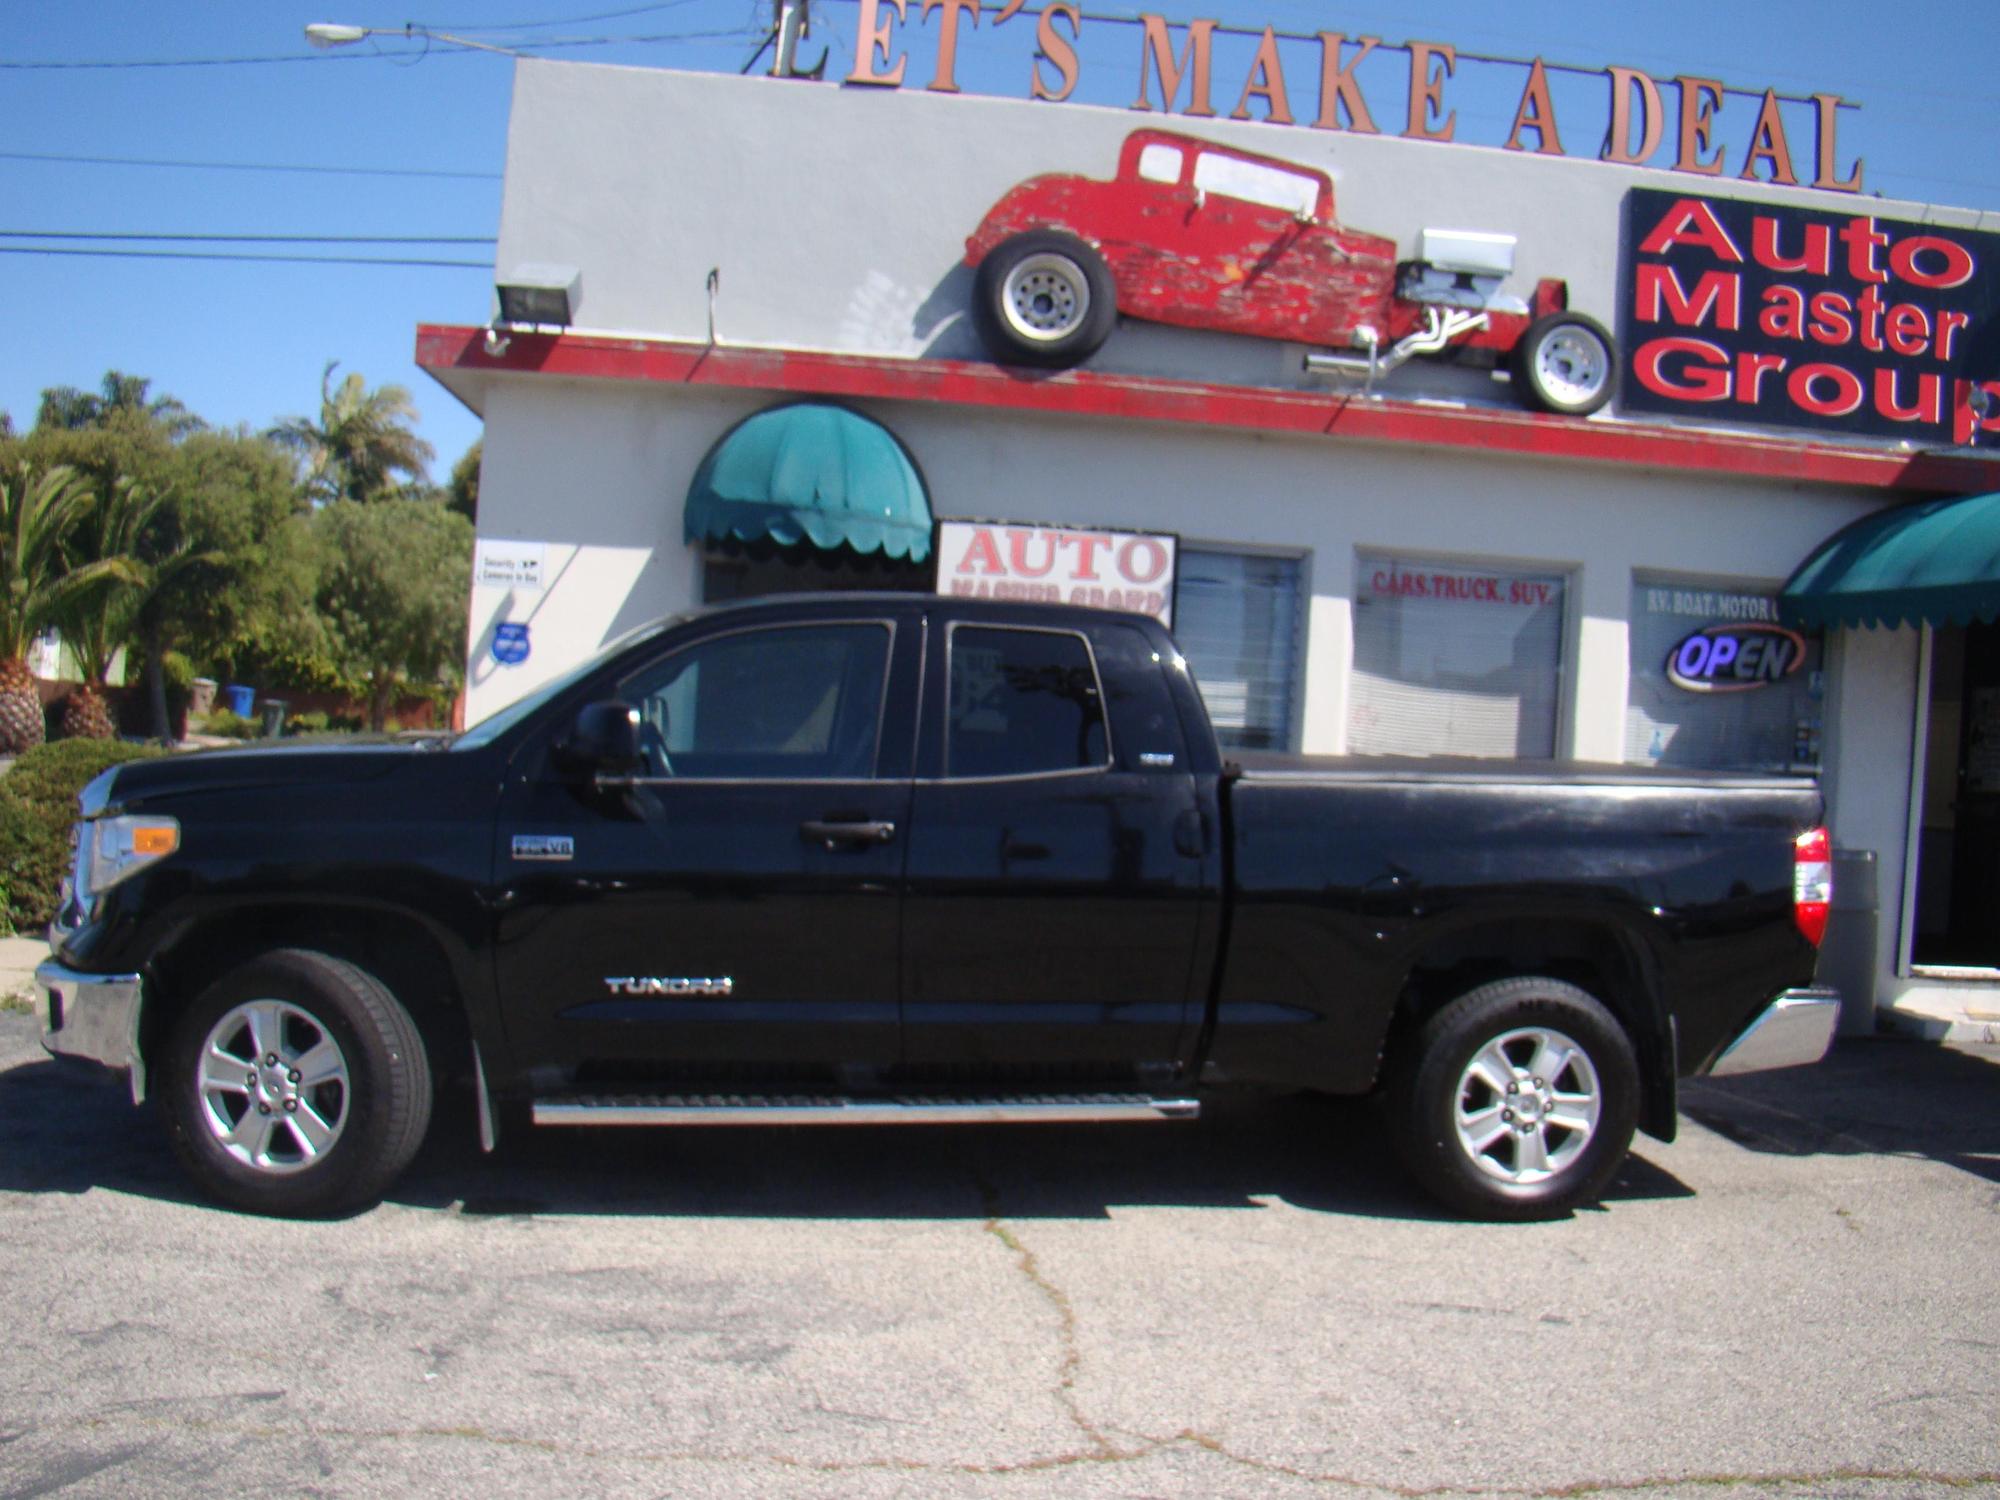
[1626,574,1826,770]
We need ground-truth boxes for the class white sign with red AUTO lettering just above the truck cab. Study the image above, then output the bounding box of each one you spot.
[938,520,1176,626]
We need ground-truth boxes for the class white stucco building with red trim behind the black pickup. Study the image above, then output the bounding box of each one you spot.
[420,62,2000,1028]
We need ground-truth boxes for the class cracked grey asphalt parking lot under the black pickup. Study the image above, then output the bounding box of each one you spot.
[0,1012,2000,1496]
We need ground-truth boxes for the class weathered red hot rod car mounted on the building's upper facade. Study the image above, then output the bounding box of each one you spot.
[966,130,1614,416]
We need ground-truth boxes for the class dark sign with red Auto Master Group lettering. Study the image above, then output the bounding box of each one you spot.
[1618,188,2000,446]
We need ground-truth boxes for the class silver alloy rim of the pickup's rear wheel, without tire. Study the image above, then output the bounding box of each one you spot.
[1454,1026,1604,1184]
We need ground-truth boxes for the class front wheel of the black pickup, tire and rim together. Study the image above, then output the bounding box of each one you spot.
[158,948,432,1218]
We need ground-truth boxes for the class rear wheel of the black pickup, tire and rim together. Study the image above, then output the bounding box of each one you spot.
[1390,978,1638,1220]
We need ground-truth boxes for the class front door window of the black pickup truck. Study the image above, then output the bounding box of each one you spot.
[620,624,890,780]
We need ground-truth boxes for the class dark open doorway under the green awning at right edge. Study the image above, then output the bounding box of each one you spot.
[1910,624,2000,970]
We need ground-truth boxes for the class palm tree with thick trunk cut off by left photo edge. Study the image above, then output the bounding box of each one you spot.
[0,462,135,754]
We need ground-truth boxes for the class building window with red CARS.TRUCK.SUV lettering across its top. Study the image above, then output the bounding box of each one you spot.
[1348,556,1568,760]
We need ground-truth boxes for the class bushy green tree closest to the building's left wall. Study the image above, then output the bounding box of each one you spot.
[314,500,472,730]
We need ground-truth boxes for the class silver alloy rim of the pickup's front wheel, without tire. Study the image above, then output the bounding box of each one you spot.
[196,1000,354,1174]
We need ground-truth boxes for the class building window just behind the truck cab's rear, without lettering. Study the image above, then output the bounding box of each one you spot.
[1174,546,1300,750]
